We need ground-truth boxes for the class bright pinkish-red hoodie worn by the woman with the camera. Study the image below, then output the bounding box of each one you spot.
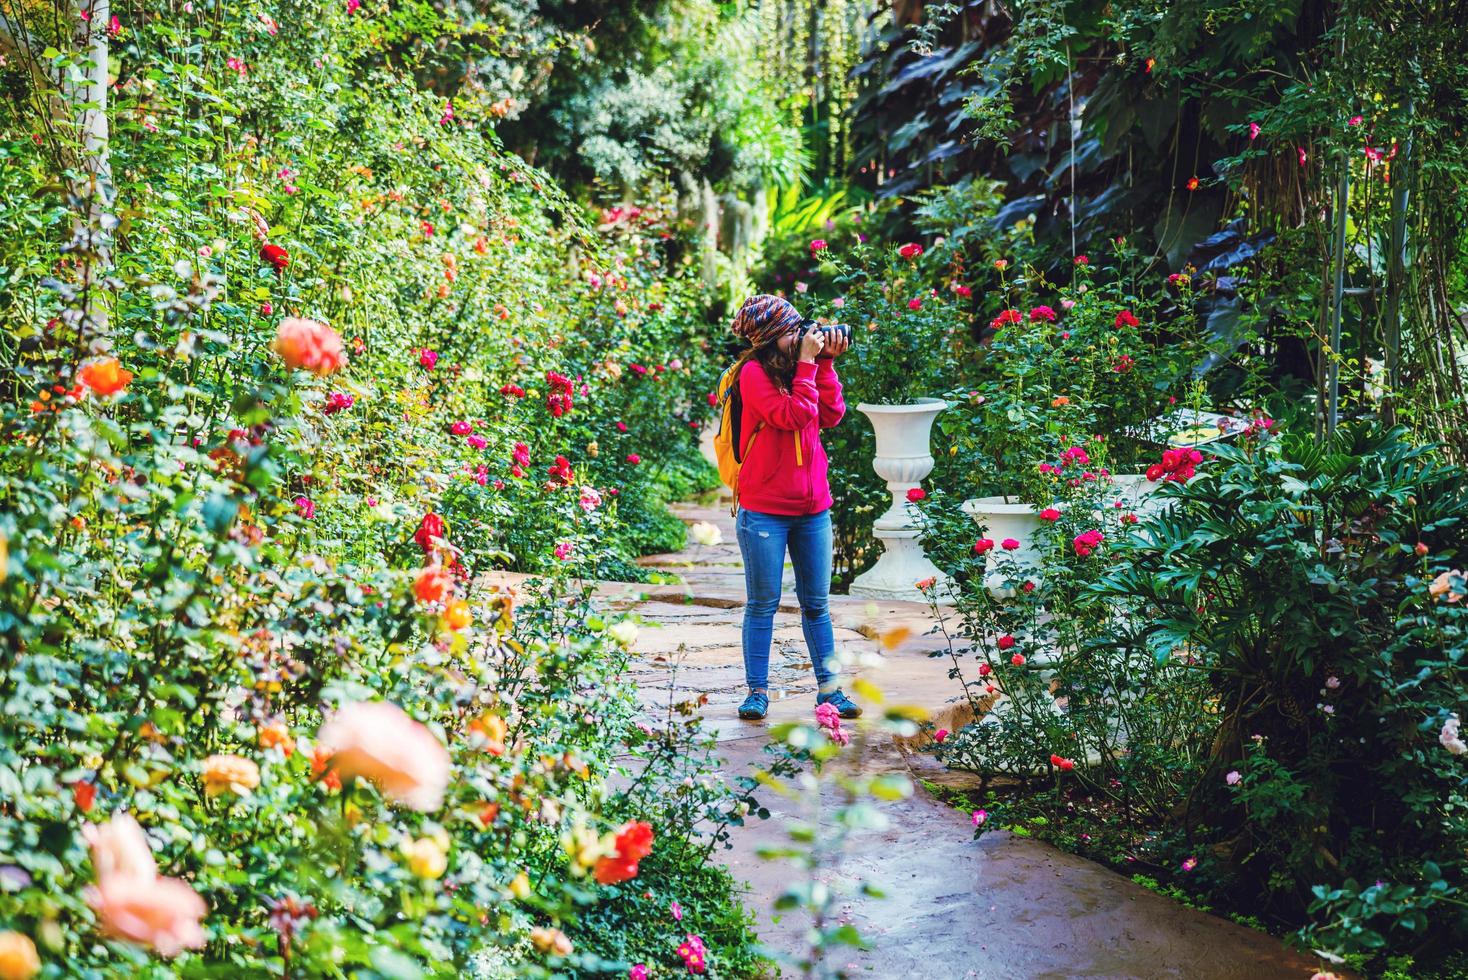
[738,358,846,516]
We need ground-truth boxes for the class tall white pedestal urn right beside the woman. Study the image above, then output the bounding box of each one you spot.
[851,398,948,601]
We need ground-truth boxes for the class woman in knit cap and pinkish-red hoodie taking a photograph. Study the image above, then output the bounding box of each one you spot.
[734,296,862,720]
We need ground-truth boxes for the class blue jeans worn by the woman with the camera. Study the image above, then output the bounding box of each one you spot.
[734,508,835,692]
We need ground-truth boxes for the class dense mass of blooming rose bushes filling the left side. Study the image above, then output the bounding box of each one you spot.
[0,3,756,976]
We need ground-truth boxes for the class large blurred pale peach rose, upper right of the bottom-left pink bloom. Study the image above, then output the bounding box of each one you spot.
[319,701,451,813]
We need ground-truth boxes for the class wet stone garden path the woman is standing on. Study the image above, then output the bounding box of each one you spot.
[490,505,1317,980]
